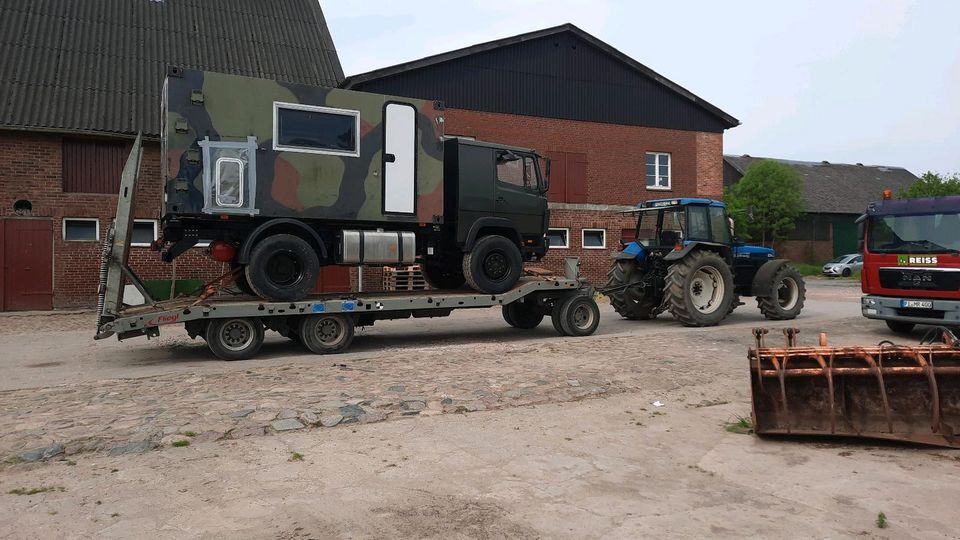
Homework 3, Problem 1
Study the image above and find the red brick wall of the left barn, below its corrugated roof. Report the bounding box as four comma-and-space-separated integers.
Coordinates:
0, 131, 221, 308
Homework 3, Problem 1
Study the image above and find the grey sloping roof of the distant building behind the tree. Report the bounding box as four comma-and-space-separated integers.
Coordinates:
723, 155, 918, 214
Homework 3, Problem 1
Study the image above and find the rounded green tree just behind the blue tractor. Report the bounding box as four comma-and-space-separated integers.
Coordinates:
724, 159, 803, 245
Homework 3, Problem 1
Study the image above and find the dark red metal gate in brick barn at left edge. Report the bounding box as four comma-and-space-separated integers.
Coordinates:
0, 219, 53, 311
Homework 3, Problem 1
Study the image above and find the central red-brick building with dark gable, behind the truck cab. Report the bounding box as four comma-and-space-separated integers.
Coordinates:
343, 24, 739, 284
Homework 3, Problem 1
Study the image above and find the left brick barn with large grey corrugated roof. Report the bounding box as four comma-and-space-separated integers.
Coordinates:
0, 0, 346, 310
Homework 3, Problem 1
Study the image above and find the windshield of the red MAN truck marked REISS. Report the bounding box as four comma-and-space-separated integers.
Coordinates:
867, 213, 960, 253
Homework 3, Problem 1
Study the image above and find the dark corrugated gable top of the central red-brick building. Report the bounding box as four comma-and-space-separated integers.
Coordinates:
343, 23, 740, 132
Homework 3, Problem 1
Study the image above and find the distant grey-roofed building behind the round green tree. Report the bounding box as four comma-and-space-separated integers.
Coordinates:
723, 155, 918, 264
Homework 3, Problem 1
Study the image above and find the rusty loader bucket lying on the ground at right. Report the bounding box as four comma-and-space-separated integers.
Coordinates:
748, 328, 960, 448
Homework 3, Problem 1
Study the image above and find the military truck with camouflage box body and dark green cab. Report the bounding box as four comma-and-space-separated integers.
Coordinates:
155, 68, 549, 301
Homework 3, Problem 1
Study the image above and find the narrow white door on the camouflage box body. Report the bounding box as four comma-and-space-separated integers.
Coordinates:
383, 103, 417, 214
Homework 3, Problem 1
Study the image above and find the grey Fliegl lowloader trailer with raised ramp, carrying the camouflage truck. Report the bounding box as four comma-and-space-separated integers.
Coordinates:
95, 137, 600, 360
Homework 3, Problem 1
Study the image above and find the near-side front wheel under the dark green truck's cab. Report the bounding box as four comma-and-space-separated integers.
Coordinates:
463, 234, 523, 294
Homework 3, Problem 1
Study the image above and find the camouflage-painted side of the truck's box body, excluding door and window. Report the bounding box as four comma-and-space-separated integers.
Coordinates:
162, 69, 443, 223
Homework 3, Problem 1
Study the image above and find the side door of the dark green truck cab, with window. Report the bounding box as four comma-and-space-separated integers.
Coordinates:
495, 152, 547, 242
